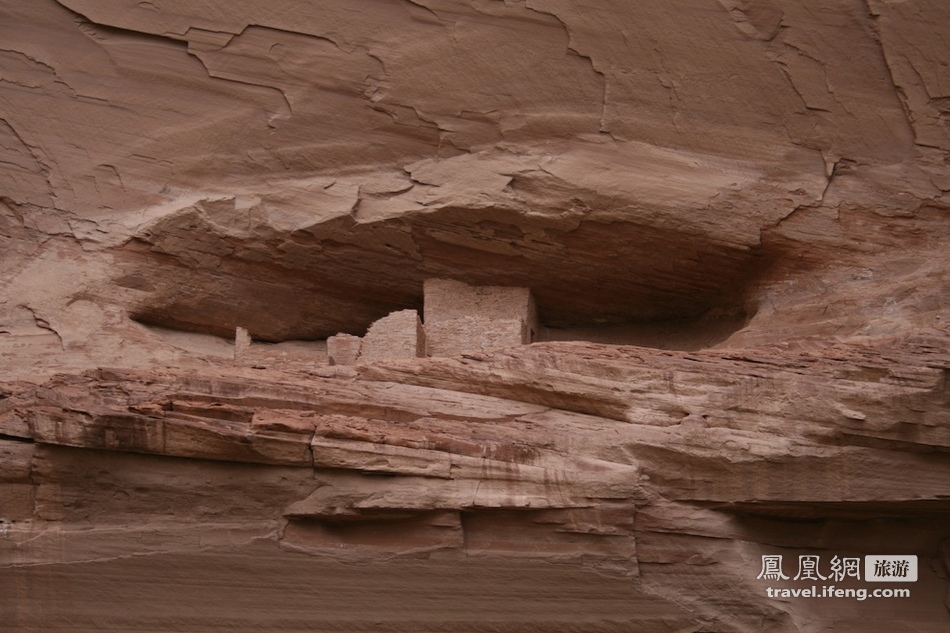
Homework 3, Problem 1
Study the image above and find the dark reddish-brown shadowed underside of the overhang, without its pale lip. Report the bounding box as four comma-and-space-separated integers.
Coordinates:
118, 201, 764, 340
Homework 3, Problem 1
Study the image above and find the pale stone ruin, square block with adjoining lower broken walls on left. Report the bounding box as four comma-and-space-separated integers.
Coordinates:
327, 279, 538, 365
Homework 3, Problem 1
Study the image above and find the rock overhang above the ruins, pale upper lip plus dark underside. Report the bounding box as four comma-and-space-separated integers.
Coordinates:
118, 142, 823, 341
